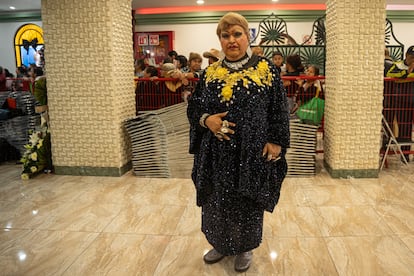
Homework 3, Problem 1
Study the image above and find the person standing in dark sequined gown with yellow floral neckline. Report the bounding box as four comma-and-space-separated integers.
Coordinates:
187, 12, 289, 271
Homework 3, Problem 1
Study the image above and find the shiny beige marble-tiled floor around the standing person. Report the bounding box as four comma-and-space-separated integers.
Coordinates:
0, 157, 414, 276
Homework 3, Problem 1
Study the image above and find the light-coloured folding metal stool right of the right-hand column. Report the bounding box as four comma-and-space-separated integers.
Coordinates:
380, 115, 414, 171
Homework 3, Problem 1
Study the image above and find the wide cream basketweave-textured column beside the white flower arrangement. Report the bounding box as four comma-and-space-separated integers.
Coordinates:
42, 0, 135, 176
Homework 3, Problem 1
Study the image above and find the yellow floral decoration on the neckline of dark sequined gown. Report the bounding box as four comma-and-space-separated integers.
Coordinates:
206, 60, 272, 103
